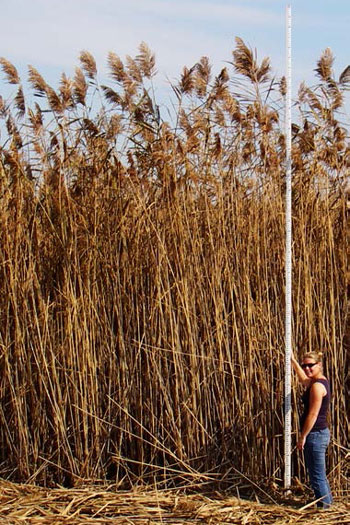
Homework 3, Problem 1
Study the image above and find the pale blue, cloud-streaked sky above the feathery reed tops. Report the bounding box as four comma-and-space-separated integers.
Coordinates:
0, 0, 350, 103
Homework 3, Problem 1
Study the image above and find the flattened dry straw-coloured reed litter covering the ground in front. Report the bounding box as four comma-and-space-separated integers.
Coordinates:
0, 481, 350, 525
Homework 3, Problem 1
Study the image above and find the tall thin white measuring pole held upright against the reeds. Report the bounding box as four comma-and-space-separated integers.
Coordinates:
284, 5, 292, 488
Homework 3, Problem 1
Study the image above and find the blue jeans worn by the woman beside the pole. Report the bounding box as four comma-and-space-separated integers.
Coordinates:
304, 428, 333, 508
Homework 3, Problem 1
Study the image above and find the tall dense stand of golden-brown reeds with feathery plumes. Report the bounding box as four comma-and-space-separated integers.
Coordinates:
0, 39, 350, 489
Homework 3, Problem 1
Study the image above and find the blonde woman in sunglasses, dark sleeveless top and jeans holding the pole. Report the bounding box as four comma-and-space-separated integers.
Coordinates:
292, 352, 333, 508
